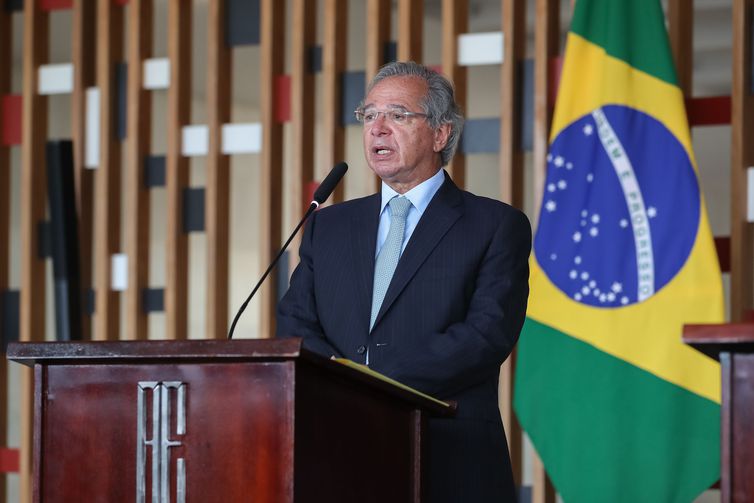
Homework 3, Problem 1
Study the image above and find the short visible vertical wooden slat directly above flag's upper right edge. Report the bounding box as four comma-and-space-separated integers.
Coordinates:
668, 0, 694, 97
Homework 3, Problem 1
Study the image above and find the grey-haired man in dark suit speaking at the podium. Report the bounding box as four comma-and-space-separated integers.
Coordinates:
277, 62, 531, 503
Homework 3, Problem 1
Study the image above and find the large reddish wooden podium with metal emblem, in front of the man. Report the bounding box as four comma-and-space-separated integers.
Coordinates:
7, 339, 448, 503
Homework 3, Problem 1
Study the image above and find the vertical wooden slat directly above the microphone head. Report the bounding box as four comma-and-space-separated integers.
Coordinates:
322, 0, 350, 202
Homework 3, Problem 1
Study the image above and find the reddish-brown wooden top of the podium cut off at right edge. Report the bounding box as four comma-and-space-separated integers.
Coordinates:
683, 323, 754, 359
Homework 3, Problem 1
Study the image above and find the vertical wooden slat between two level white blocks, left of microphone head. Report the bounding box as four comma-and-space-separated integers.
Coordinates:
204, 0, 233, 338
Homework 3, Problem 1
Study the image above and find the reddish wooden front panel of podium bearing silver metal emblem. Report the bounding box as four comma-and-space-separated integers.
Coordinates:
35, 361, 294, 502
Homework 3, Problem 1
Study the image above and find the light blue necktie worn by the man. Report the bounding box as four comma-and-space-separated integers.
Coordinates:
369, 197, 411, 330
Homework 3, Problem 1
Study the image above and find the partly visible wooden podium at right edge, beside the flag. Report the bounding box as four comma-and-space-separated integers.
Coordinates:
683, 323, 754, 503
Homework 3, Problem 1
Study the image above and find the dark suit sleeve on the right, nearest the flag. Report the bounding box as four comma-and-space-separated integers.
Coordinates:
375, 211, 531, 398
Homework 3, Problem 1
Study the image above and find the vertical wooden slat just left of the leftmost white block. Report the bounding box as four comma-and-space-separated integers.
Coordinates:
19, 0, 49, 502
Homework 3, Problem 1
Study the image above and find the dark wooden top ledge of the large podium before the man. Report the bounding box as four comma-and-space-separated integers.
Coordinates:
6, 337, 455, 415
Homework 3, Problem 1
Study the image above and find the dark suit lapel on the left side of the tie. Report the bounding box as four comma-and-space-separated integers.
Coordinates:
350, 193, 382, 331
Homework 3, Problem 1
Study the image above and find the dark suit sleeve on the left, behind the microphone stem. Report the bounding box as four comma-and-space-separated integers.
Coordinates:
276, 213, 342, 357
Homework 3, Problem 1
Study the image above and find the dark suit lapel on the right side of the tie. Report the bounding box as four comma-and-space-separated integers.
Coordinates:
370, 177, 463, 327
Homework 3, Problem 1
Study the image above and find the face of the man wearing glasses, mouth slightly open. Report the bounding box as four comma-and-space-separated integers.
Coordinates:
363, 76, 450, 193
